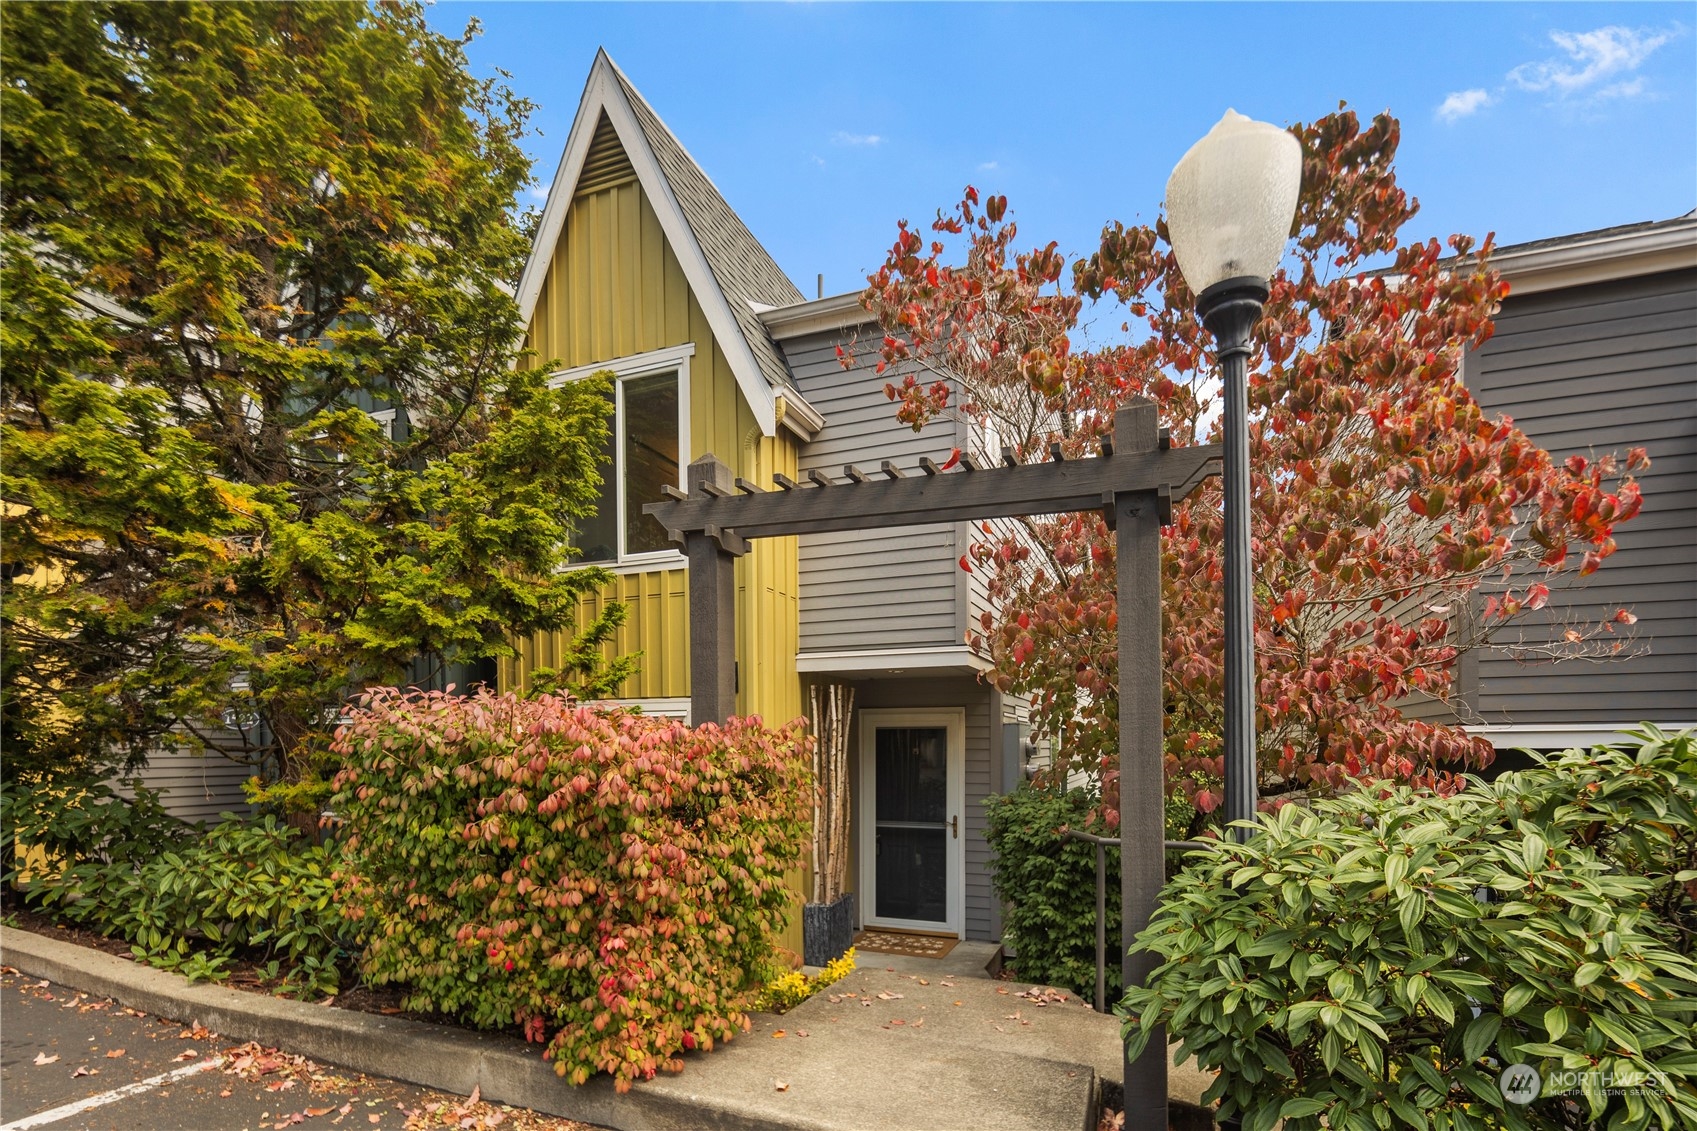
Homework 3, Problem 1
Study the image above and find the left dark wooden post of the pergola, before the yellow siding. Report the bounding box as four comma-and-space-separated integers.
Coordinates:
684, 455, 736, 727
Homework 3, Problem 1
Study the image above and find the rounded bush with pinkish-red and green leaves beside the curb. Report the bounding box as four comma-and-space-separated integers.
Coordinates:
334, 689, 813, 1090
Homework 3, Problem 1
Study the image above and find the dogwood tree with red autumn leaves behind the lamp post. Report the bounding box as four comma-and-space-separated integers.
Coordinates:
864, 110, 1646, 830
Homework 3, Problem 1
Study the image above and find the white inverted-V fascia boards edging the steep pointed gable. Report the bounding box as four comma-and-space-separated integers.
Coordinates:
519, 51, 777, 436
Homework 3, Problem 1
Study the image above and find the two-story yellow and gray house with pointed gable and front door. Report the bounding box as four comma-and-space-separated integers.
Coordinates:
502, 53, 1015, 949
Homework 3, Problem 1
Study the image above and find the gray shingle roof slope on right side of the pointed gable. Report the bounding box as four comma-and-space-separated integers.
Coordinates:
613, 66, 803, 387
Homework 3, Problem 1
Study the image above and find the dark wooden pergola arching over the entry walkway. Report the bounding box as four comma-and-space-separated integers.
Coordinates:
643, 399, 1222, 1128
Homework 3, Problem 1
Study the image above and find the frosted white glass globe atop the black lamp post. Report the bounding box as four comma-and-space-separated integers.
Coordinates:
1166, 110, 1302, 294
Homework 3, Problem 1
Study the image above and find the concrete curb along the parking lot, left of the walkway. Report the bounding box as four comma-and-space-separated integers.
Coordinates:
0, 926, 797, 1131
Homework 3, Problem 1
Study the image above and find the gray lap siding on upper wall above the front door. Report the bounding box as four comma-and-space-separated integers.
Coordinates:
781, 329, 966, 652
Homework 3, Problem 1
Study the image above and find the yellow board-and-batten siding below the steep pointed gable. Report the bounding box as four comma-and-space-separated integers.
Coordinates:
501, 117, 803, 723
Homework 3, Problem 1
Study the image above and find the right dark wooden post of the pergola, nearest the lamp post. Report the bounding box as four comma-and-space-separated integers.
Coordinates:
1113, 397, 1168, 1128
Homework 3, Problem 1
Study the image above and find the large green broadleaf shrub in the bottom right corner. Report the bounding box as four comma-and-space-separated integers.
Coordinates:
1123, 730, 1697, 1131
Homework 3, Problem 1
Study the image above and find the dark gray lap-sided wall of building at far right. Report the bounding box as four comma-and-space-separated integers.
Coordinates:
1463, 270, 1697, 730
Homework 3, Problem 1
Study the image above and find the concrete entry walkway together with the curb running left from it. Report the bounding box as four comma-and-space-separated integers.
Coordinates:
0, 927, 1205, 1131
